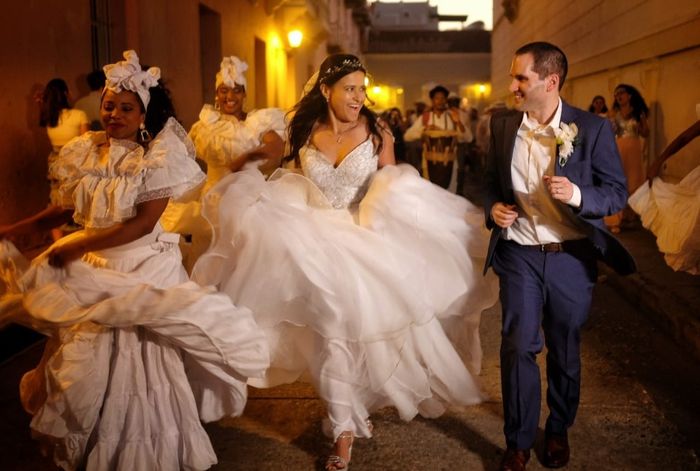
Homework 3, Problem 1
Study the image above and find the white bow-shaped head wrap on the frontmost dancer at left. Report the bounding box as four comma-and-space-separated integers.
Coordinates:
103, 50, 160, 108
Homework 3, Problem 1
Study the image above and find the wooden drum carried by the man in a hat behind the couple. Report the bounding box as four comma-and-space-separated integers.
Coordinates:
421, 129, 457, 189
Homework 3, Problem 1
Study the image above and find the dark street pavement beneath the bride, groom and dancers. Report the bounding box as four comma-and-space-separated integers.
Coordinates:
0, 283, 700, 471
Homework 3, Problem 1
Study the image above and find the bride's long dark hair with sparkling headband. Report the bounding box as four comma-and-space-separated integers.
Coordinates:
284, 54, 382, 167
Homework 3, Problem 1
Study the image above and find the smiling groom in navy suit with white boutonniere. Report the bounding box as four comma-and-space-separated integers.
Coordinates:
484, 42, 635, 471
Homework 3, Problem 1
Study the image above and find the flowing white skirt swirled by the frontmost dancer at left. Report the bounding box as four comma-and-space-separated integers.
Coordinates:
0, 228, 269, 471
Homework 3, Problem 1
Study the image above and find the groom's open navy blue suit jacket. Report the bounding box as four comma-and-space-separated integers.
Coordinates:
484, 101, 636, 275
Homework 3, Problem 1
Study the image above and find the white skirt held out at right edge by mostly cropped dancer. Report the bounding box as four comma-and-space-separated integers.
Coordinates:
629, 167, 700, 275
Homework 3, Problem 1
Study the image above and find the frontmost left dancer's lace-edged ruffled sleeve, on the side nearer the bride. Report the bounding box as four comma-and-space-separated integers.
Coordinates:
136, 118, 206, 204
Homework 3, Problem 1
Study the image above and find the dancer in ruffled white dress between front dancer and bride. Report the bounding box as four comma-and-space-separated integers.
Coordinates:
161, 56, 286, 271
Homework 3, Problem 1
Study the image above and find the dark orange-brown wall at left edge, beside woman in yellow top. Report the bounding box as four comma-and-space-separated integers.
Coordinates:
0, 0, 92, 224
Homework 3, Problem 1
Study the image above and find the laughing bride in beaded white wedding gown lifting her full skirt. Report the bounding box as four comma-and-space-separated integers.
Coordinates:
193, 54, 497, 469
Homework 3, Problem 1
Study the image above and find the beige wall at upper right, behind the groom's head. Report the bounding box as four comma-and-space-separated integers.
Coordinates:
491, 0, 700, 180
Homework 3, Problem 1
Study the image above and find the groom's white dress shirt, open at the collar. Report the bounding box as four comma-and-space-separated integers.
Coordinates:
503, 99, 585, 245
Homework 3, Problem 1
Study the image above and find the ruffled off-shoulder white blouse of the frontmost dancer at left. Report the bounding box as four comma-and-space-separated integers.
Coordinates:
49, 118, 206, 228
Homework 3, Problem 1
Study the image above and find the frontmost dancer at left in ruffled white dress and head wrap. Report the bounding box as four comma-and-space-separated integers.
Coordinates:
0, 51, 269, 471
